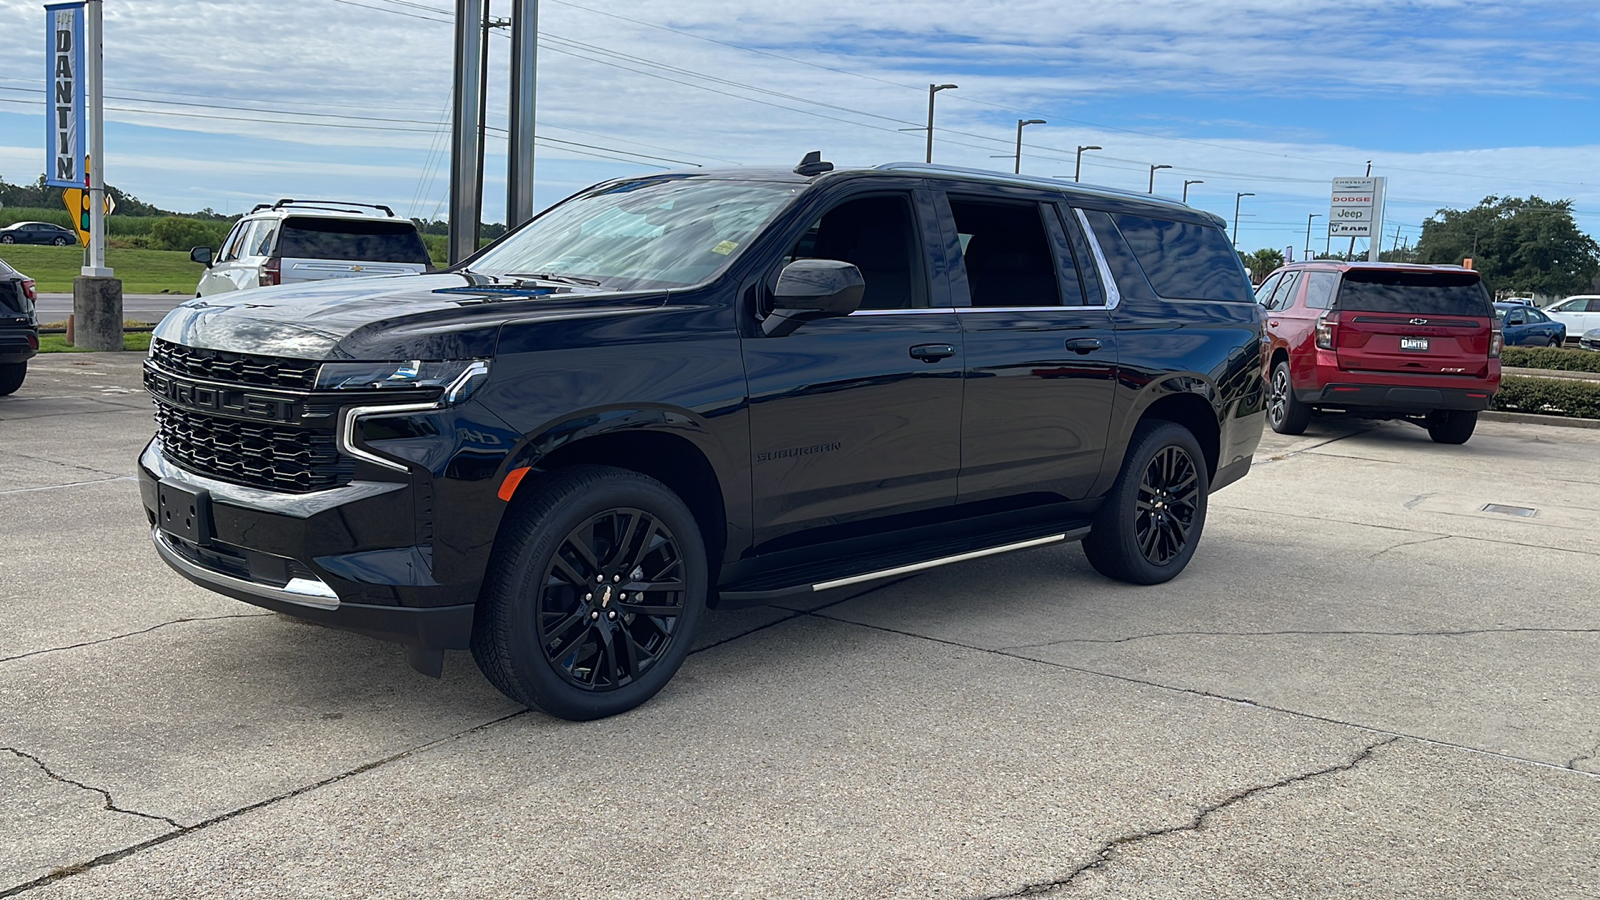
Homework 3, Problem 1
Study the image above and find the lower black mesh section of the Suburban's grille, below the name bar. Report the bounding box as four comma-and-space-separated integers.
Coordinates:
155, 393, 355, 493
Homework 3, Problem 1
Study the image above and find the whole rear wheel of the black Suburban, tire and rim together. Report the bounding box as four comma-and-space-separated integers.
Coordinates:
1083, 420, 1211, 585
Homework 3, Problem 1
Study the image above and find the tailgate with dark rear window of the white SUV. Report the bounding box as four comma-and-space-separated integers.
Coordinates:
274, 216, 429, 285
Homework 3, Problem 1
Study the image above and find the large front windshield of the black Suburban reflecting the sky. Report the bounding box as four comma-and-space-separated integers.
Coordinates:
470, 176, 803, 290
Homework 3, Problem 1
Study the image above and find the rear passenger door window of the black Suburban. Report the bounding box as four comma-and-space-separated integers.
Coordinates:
950, 195, 1062, 306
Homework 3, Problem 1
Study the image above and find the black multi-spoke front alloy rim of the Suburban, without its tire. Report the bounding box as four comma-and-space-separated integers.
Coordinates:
534, 509, 686, 692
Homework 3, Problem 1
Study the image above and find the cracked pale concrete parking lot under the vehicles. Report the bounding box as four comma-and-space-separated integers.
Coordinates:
0, 354, 1600, 900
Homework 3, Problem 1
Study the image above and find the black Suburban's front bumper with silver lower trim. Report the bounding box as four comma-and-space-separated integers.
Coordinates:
139, 440, 478, 650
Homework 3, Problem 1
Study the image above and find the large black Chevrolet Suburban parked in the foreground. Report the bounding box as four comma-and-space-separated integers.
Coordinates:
139, 154, 1264, 719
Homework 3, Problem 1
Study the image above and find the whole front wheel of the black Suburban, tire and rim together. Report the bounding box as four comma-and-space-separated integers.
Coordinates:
472, 466, 709, 721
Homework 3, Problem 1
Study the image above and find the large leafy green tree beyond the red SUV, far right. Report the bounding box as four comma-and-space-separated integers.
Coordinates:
1416, 197, 1600, 296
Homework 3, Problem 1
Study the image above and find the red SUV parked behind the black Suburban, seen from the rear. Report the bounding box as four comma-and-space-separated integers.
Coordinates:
1256, 259, 1501, 444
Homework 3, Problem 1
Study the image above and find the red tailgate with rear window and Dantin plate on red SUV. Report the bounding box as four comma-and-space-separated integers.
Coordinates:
1333, 269, 1494, 378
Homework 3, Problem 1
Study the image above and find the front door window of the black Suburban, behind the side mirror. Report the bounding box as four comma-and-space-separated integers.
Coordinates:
766, 194, 928, 309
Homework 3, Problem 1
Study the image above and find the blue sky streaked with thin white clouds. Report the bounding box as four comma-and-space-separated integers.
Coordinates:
0, 0, 1600, 250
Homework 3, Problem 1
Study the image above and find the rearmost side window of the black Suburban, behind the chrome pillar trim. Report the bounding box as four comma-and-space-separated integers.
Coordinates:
1112, 213, 1254, 303
